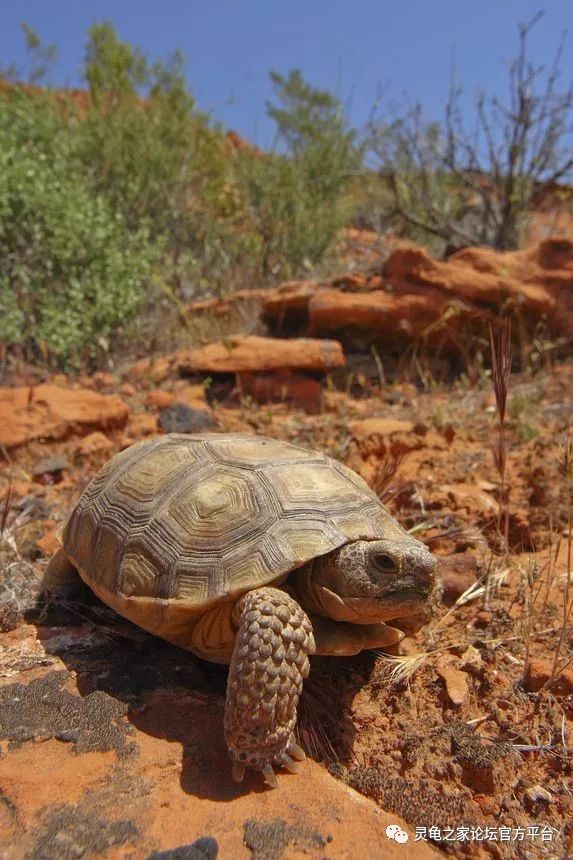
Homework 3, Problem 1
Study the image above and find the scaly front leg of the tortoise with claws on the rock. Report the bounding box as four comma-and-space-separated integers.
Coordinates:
225, 588, 315, 788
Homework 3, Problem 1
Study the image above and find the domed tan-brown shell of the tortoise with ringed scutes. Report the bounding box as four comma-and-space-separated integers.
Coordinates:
64, 434, 405, 609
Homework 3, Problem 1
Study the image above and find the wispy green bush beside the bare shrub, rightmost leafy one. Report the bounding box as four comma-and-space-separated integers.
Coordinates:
235, 69, 361, 276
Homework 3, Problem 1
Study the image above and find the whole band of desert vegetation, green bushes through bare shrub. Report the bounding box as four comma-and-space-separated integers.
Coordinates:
0, 15, 573, 367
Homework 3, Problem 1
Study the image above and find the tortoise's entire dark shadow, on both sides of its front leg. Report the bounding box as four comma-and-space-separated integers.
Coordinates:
28, 582, 374, 802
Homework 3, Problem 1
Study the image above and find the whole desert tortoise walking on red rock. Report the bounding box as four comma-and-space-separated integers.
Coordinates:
48, 433, 436, 786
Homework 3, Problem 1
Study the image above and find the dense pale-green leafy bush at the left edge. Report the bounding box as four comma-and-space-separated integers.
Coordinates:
0, 90, 156, 363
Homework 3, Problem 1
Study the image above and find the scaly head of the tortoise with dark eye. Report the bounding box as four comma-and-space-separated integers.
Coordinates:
300, 534, 437, 624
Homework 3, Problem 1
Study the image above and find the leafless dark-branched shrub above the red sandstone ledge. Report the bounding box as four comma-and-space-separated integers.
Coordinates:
371, 12, 573, 249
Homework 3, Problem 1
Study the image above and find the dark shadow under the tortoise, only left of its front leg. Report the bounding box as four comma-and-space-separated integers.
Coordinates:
27, 581, 241, 801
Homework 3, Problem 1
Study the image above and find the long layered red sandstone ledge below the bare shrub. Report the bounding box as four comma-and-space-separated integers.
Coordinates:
264, 239, 573, 348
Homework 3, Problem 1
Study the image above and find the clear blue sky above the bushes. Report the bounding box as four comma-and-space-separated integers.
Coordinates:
0, 0, 573, 146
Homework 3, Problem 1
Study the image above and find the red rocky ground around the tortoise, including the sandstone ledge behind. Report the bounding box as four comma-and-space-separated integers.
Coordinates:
0, 241, 573, 860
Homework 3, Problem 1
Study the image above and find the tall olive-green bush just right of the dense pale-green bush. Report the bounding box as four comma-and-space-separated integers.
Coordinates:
80, 24, 248, 295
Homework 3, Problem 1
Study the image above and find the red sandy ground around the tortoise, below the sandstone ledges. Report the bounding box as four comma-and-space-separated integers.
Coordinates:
0, 352, 573, 860
